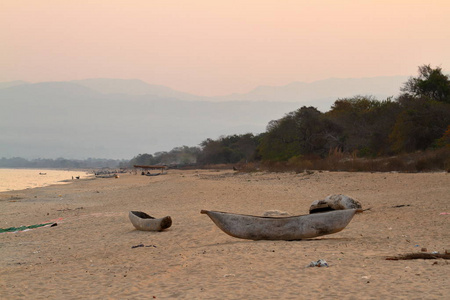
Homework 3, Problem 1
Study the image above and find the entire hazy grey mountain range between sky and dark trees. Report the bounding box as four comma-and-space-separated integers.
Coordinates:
0, 76, 407, 159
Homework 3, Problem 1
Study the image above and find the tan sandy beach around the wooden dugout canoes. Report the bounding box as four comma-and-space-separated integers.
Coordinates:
0, 170, 450, 299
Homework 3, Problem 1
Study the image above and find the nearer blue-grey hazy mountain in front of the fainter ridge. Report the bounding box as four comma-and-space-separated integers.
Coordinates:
0, 82, 299, 159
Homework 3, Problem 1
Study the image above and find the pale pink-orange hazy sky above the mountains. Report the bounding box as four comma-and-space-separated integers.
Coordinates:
0, 0, 450, 96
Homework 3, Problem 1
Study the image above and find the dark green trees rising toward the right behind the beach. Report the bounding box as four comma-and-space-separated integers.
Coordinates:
131, 65, 450, 170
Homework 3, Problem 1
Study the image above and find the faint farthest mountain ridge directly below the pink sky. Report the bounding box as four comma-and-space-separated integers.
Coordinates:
72, 76, 408, 111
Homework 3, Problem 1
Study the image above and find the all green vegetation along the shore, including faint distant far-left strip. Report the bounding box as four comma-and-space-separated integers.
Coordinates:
4, 65, 450, 172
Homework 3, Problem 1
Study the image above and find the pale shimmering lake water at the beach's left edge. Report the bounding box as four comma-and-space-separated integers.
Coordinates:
0, 169, 92, 192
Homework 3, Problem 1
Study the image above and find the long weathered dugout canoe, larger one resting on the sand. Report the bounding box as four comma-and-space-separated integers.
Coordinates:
201, 209, 356, 241
